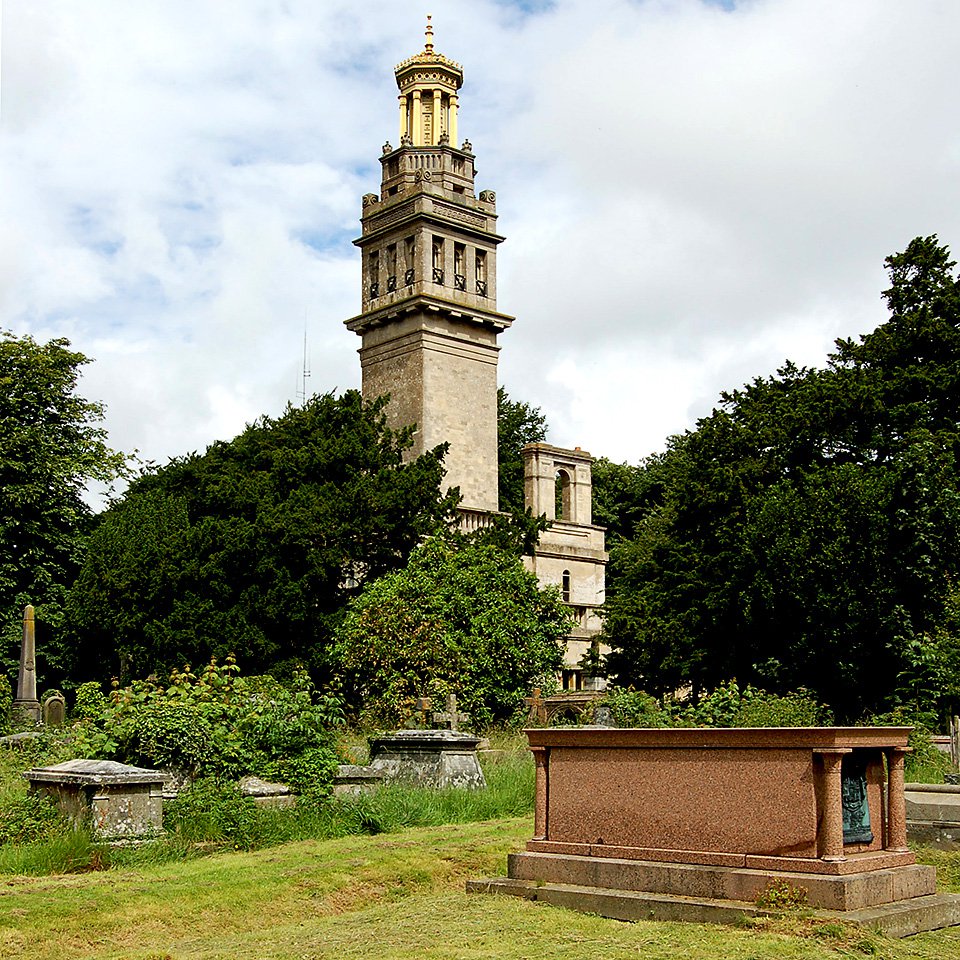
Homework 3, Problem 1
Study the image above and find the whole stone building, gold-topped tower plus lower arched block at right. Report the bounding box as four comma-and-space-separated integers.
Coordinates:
346, 18, 607, 689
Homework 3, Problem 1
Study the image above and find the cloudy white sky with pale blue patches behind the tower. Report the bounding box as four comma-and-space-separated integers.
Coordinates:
0, 0, 960, 496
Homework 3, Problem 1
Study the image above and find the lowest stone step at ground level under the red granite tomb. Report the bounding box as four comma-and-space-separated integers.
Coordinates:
466, 877, 960, 937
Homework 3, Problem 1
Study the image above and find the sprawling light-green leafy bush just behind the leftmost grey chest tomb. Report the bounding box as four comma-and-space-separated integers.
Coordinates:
75, 657, 343, 792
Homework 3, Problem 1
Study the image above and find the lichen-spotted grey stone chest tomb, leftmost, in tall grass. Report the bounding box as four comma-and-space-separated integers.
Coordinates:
23, 760, 164, 840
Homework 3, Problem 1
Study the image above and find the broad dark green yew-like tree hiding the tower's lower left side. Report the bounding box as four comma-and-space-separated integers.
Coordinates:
69, 391, 457, 679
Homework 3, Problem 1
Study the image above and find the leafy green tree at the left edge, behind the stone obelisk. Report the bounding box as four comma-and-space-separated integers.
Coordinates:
0, 330, 124, 685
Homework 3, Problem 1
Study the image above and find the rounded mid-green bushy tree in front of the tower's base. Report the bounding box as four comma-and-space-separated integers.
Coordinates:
337, 537, 570, 723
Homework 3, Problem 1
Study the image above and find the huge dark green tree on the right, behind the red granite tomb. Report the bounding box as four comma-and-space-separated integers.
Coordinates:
606, 237, 960, 719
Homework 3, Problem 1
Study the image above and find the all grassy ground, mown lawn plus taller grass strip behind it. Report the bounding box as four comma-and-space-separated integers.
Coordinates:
0, 741, 960, 960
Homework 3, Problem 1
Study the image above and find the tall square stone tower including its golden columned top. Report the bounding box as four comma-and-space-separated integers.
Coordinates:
346, 17, 513, 512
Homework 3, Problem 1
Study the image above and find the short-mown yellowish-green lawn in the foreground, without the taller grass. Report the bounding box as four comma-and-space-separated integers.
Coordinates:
0, 817, 960, 960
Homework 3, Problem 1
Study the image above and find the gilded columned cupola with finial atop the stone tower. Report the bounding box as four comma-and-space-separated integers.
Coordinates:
395, 16, 463, 147
